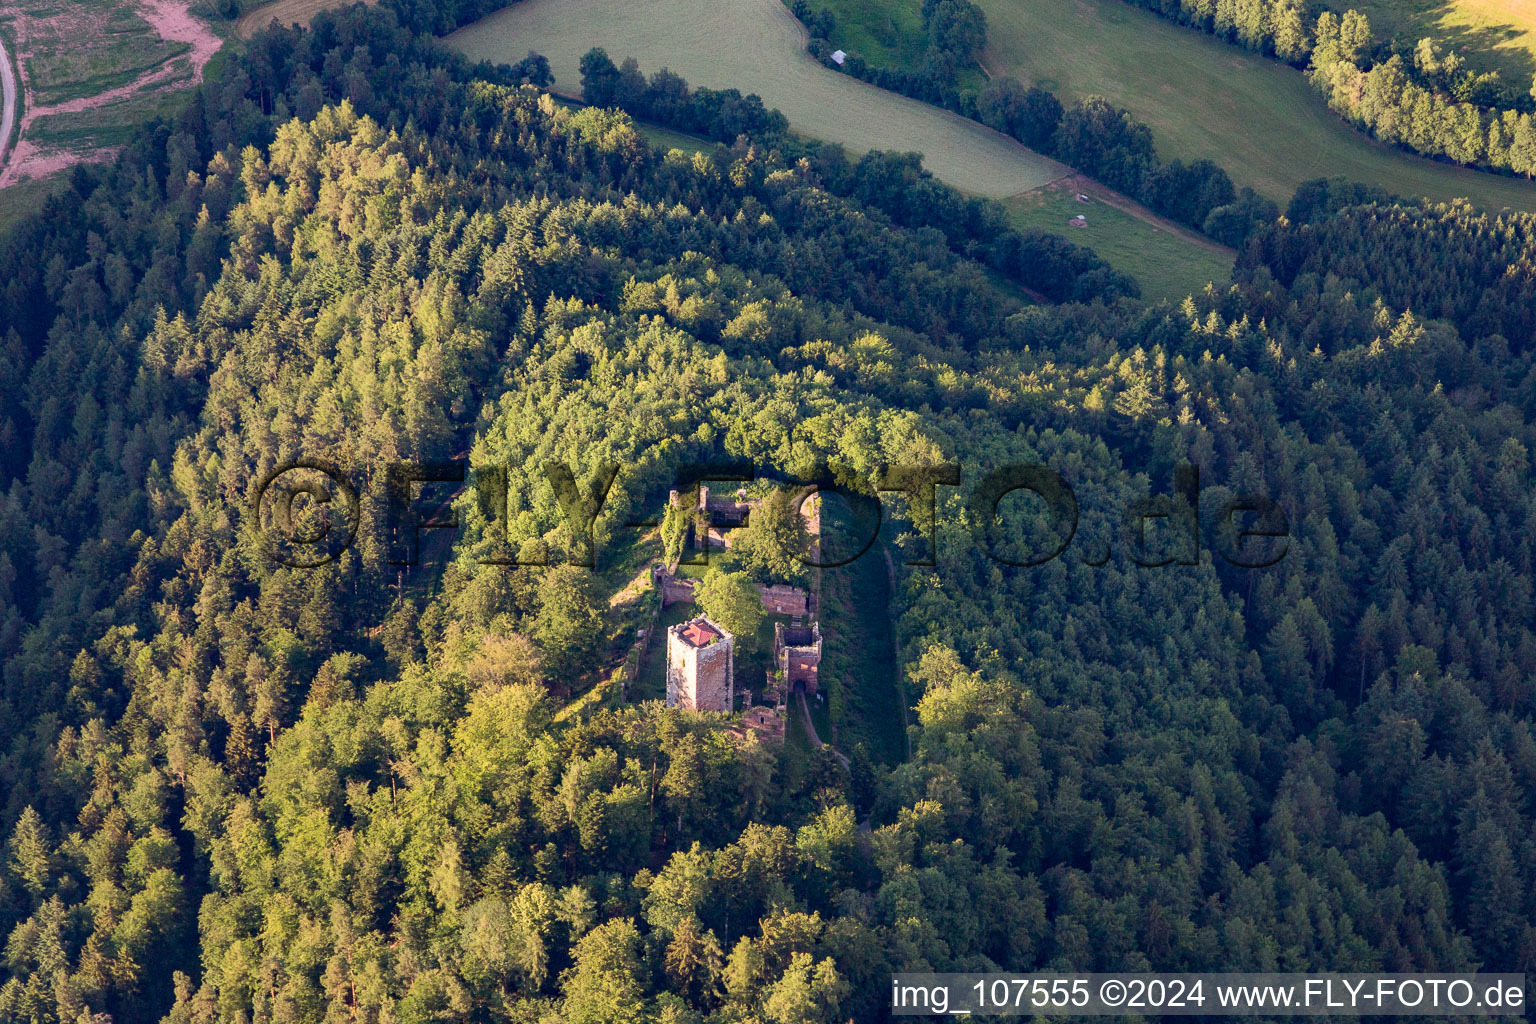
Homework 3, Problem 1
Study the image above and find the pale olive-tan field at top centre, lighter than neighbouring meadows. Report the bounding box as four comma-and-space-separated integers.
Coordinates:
449, 0, 1068, 198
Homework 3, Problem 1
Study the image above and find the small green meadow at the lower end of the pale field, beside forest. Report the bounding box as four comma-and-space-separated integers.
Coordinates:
1003, 178, 1235, 302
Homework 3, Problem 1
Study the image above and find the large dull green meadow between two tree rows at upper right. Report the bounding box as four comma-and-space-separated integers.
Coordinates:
976, 0, 1536, 210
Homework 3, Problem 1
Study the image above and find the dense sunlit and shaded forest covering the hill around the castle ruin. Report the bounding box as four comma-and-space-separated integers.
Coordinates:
0, 8, 1536, 1024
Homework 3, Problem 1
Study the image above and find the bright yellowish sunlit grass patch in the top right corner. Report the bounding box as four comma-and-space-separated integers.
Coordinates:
1349, 0, 1536, 86
